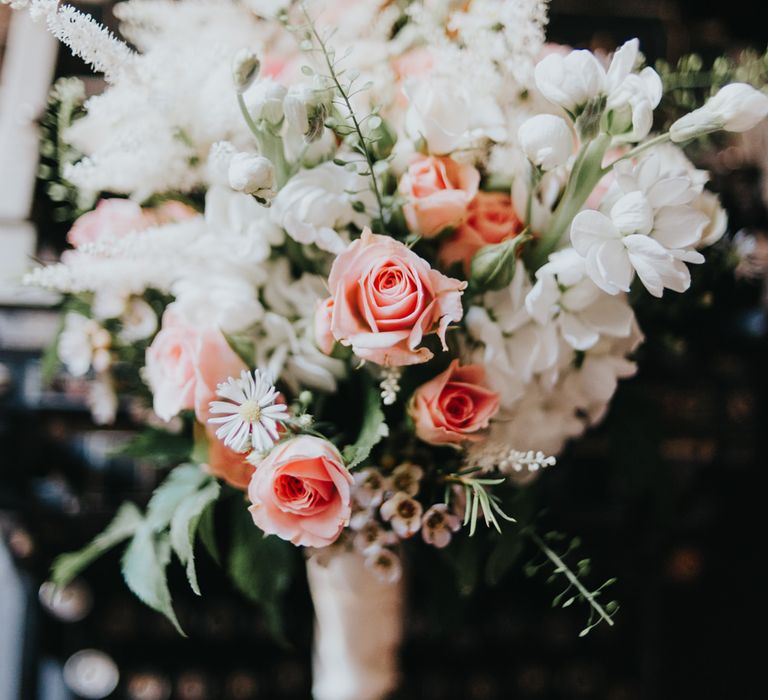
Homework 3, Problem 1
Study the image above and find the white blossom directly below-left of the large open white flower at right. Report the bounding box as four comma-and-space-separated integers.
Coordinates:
525, 248, 634, 350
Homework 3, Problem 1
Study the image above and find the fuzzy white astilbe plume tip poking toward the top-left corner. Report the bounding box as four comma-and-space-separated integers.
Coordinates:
29, 0, 136, 83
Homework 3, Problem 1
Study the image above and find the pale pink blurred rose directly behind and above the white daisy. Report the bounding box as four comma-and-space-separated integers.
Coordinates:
145, 313, 248, 424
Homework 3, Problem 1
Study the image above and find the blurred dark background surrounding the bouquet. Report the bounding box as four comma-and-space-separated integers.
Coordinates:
0, 0, 768, 700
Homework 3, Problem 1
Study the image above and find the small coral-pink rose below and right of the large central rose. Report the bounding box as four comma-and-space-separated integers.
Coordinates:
408, 360, 499, 445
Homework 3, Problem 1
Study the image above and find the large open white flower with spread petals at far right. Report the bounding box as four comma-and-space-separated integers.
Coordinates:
571, 154, 709, 297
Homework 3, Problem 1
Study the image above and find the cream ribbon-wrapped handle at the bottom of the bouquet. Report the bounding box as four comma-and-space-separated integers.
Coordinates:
307, 552, 403, 700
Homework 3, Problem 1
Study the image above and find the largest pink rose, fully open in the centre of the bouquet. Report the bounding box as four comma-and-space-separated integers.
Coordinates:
328, 229, 467, 367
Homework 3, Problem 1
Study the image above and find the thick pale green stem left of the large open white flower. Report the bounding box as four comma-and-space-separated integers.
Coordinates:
529, 134, 611, 270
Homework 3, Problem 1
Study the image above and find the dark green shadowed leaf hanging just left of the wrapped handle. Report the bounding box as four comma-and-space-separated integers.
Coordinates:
227, 499, 296, 644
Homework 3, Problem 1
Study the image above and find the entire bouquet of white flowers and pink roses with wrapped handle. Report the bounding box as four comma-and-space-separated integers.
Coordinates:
7, 0, 768, 700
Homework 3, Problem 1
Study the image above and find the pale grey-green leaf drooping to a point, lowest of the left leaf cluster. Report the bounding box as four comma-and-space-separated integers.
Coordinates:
122, 520, 187, 637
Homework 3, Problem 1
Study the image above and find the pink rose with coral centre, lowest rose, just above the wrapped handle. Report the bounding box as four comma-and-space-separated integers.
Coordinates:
248, 435, 352, 547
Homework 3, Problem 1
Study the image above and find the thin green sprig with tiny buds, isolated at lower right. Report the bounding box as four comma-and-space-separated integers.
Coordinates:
525, 527, 619, 637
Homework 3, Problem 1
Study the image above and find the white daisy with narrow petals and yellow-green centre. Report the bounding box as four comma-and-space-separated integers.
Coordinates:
208, 369, 288, 452
